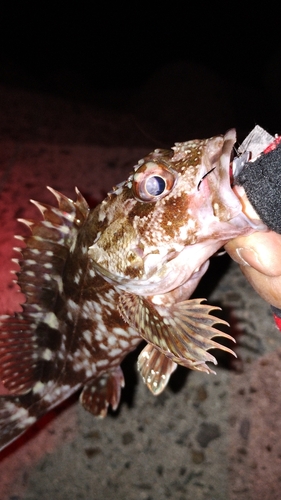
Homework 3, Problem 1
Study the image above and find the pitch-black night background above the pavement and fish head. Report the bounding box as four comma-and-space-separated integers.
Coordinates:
0, 1, 281, 140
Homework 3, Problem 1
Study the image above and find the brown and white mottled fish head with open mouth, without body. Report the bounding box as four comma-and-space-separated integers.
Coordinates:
89, 129, 256, 294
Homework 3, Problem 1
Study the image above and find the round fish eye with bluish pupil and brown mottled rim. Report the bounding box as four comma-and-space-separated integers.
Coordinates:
133, 161, 176, 202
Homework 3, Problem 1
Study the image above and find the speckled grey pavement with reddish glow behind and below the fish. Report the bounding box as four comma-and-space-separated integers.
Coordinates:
0, 71, 281, 500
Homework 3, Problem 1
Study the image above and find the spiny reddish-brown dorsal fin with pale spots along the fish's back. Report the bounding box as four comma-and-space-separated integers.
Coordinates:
0, 188, 89, 394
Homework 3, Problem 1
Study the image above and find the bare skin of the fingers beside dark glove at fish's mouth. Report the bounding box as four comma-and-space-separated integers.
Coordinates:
225, 188, 281, 309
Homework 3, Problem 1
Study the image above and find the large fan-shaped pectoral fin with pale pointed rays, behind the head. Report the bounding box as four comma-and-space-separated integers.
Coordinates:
119, 293, 236, 373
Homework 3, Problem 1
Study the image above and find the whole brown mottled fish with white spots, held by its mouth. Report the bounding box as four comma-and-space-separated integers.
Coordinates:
0, 129, 258, 449
